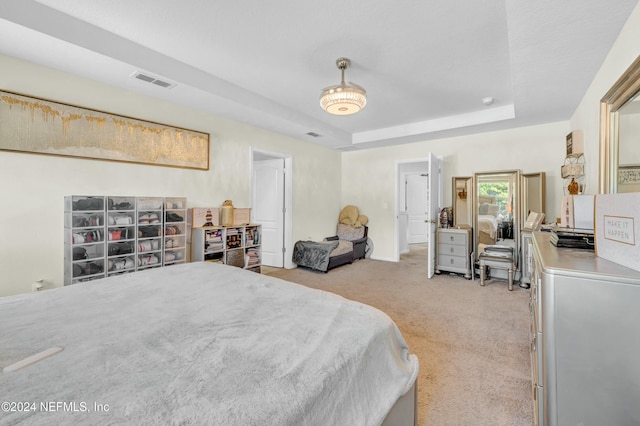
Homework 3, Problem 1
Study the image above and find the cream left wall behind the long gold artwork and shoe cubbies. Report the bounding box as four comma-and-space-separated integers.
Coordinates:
0, 56, 341, 296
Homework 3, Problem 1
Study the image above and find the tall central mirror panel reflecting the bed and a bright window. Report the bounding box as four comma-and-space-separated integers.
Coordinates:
473, 170, 521, 260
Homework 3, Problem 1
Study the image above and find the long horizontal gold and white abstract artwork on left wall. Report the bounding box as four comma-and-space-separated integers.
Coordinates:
0, 91, 209, 170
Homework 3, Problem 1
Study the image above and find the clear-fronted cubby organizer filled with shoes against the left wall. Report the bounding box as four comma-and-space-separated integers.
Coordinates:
64, 195, 187, 285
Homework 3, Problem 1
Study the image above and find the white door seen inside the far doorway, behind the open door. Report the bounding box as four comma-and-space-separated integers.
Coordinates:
405, 173, 429, 244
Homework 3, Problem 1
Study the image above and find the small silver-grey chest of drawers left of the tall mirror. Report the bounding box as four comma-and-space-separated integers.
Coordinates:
435, 228, 471, 279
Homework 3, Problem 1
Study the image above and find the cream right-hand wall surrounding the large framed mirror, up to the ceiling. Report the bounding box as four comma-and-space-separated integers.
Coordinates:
571, 3, 640, 194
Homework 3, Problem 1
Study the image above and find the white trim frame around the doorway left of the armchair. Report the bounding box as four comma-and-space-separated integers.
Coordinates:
249, 147, 296, 269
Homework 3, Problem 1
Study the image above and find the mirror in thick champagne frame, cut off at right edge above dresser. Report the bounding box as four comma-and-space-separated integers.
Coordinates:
598, 56, 640, 194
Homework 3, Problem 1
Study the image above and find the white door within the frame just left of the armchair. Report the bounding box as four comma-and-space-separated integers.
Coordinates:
251, 158, 284, 268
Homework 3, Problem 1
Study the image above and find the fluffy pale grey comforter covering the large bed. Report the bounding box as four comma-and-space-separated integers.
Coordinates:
0, 262, 418, 425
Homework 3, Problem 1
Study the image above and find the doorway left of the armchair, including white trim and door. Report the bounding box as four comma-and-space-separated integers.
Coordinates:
251, 149, 294, 269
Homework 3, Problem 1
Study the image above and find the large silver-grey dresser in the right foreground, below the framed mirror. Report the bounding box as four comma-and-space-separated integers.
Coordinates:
530, 232, 640, 426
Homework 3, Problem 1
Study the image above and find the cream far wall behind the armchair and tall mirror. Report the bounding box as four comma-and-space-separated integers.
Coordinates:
342, 121, 569, 261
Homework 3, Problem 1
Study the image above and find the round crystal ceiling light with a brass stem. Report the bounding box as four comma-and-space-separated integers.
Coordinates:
320, 58, 367, 115
